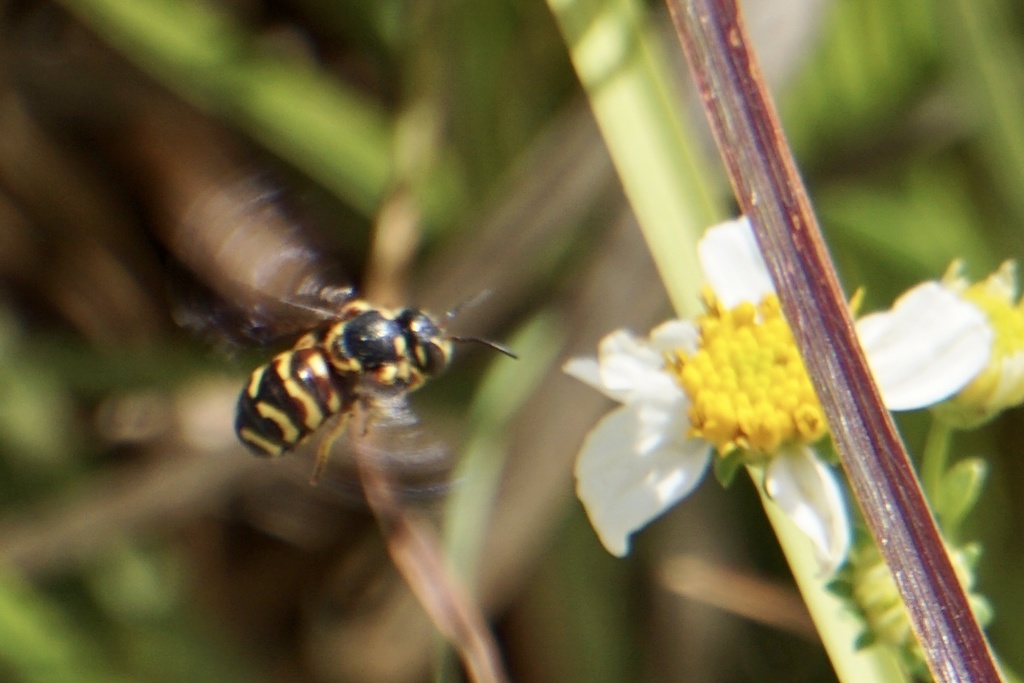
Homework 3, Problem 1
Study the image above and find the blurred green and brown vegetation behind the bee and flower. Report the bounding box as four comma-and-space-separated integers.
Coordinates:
0, 0, 1024, 683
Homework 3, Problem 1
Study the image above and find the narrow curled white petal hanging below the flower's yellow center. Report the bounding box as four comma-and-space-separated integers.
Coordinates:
765, 447, 850, 577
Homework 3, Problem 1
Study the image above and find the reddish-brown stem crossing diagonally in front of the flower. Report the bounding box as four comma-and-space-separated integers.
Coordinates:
668, 0, 999, 681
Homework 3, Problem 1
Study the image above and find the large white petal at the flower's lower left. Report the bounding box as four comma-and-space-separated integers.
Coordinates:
575, 405, 710, 557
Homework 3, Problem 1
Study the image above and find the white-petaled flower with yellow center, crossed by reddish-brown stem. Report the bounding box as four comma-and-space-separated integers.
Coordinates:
564, 218, 991, 573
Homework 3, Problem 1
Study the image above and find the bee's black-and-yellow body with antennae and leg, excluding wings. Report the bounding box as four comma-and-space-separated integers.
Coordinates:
234, 298, 515, 483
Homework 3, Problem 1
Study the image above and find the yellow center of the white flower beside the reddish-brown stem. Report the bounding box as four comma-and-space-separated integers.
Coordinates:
668, 290, 826, 455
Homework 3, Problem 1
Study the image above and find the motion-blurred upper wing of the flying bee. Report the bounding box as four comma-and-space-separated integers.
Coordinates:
165, 177, 354, 346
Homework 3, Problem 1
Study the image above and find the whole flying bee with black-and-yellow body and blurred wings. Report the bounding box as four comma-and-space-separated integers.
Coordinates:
167, 176, 514, 481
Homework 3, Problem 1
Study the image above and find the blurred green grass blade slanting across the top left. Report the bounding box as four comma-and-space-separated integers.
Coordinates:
51, 0, 460, 223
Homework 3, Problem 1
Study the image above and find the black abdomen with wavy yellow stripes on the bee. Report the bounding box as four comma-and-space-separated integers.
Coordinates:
234, 348, 353, 457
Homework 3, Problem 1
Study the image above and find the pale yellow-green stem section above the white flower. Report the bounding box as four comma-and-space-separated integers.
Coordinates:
548, 0, 722, 315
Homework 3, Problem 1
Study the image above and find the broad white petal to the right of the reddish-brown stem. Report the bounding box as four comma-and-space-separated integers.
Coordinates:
857, 282, 992, 411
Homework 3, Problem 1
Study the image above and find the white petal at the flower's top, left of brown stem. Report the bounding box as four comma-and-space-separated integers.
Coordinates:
697, 216, 775, 308
